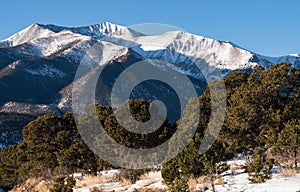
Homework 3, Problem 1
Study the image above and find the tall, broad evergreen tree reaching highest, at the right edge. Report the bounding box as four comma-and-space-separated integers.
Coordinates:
226, 63, 300, 152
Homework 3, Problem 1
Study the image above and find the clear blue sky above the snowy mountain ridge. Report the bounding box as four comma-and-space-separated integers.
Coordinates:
0, 0, 300, 56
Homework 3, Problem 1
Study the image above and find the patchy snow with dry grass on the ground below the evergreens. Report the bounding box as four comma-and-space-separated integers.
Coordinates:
74, 157, 300, 192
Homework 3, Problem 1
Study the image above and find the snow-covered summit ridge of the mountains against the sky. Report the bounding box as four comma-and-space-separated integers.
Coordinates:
0, 22, 300, 70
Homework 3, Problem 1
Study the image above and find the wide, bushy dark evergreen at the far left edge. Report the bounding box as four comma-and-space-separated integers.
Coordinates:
0, 114, 97, 188
